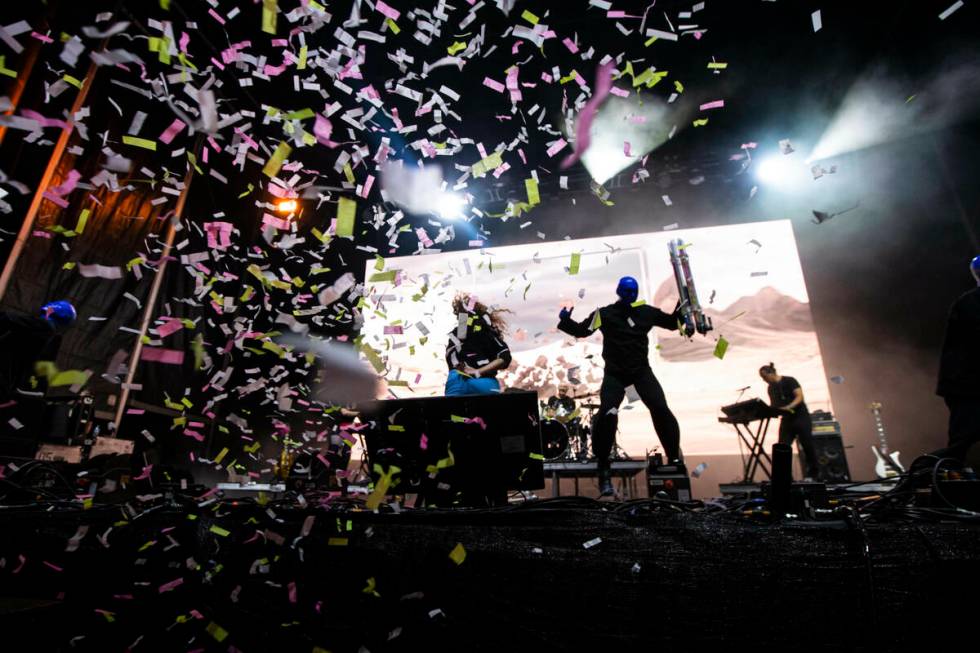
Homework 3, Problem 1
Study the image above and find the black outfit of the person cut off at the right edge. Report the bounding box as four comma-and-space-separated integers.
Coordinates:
933, 287, 980, 461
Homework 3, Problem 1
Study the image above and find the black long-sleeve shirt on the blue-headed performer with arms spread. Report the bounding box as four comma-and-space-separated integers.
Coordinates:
558, 301, 677, 379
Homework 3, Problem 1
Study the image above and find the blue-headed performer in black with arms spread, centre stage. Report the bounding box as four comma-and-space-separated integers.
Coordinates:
558, 277, 681, 496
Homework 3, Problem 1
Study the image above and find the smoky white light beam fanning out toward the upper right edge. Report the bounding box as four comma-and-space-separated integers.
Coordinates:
809, 52, 980, 161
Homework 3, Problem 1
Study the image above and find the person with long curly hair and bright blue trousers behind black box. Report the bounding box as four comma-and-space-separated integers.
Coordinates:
446, 295, 511, 397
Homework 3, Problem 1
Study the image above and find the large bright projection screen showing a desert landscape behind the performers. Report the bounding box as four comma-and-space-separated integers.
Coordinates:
362, 220, 831, 458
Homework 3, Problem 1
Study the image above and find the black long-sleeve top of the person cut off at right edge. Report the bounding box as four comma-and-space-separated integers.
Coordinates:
936, 287, 980, 397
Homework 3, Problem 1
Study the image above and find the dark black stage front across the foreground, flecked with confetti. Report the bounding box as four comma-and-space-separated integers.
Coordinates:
0, 497, 980, 652
